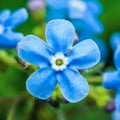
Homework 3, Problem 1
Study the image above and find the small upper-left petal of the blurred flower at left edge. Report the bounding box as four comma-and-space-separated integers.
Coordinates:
0, 9, 11, 23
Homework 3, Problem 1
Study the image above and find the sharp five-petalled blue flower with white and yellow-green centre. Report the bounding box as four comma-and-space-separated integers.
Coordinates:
18, 19, 100, 102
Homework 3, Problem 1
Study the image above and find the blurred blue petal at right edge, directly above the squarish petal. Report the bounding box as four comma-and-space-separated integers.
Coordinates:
114, 47, 120, 70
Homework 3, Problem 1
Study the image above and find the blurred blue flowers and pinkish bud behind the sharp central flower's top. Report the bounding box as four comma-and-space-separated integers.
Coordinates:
28, 0, 108, 62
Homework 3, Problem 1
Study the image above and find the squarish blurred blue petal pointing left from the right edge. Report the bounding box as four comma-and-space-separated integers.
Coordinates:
103, 71, 120, 89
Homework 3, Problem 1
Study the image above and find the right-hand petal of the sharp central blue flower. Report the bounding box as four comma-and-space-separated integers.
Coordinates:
68, 39, 100, 69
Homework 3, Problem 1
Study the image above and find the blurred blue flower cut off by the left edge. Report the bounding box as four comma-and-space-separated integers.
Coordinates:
0, 8, 28, 48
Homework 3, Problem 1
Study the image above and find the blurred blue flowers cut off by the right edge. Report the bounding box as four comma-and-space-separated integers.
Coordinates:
103, 32, 120, 120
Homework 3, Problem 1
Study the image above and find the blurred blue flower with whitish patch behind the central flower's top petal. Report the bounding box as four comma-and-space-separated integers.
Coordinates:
46, 0, 104, 37
